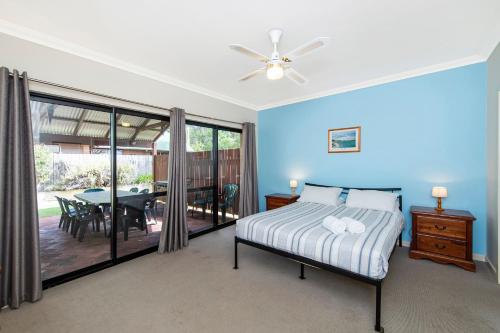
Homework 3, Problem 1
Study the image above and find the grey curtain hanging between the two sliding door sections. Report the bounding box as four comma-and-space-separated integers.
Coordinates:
158, 108, 188, 253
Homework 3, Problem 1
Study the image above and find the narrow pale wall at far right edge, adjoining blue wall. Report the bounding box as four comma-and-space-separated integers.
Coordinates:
486, 44, 500, 283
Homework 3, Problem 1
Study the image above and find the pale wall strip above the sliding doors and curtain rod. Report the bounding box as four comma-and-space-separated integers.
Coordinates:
0, 33, 257, 127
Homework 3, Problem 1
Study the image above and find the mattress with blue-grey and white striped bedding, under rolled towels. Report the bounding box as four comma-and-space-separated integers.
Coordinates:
236, 202, 404, 279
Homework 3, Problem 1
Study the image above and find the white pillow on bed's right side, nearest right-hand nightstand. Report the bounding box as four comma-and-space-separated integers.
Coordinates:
345, 189, 399, 212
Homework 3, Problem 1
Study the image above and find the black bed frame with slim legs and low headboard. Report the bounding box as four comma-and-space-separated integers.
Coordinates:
233, 183, 403, 332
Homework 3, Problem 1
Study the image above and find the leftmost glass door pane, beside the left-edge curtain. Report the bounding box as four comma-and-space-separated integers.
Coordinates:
31, 98, 111, 280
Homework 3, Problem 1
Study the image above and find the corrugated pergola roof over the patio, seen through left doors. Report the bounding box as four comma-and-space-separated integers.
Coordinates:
31, 101, 169, 142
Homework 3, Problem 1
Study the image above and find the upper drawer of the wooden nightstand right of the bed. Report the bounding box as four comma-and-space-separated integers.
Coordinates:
417, 215, 467, 240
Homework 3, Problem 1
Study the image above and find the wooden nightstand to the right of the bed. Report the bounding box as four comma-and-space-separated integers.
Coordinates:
410, 206, 476, 272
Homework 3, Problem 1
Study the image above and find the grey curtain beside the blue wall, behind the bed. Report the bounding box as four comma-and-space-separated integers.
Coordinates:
239, 123, 259, 218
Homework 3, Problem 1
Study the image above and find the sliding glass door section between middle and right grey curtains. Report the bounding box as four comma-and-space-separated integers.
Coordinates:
186, 122, 241, 228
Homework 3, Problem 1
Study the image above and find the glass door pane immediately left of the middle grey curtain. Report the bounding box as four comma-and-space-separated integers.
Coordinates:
115, 110, 170, 257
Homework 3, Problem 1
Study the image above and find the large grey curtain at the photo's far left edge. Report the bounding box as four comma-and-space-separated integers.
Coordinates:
0, 67, 42, 309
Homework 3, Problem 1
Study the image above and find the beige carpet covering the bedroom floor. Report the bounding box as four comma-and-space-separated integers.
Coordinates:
0, 227, 500, 333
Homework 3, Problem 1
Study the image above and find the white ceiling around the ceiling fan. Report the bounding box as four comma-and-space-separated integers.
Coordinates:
0, 0, 500, 109
